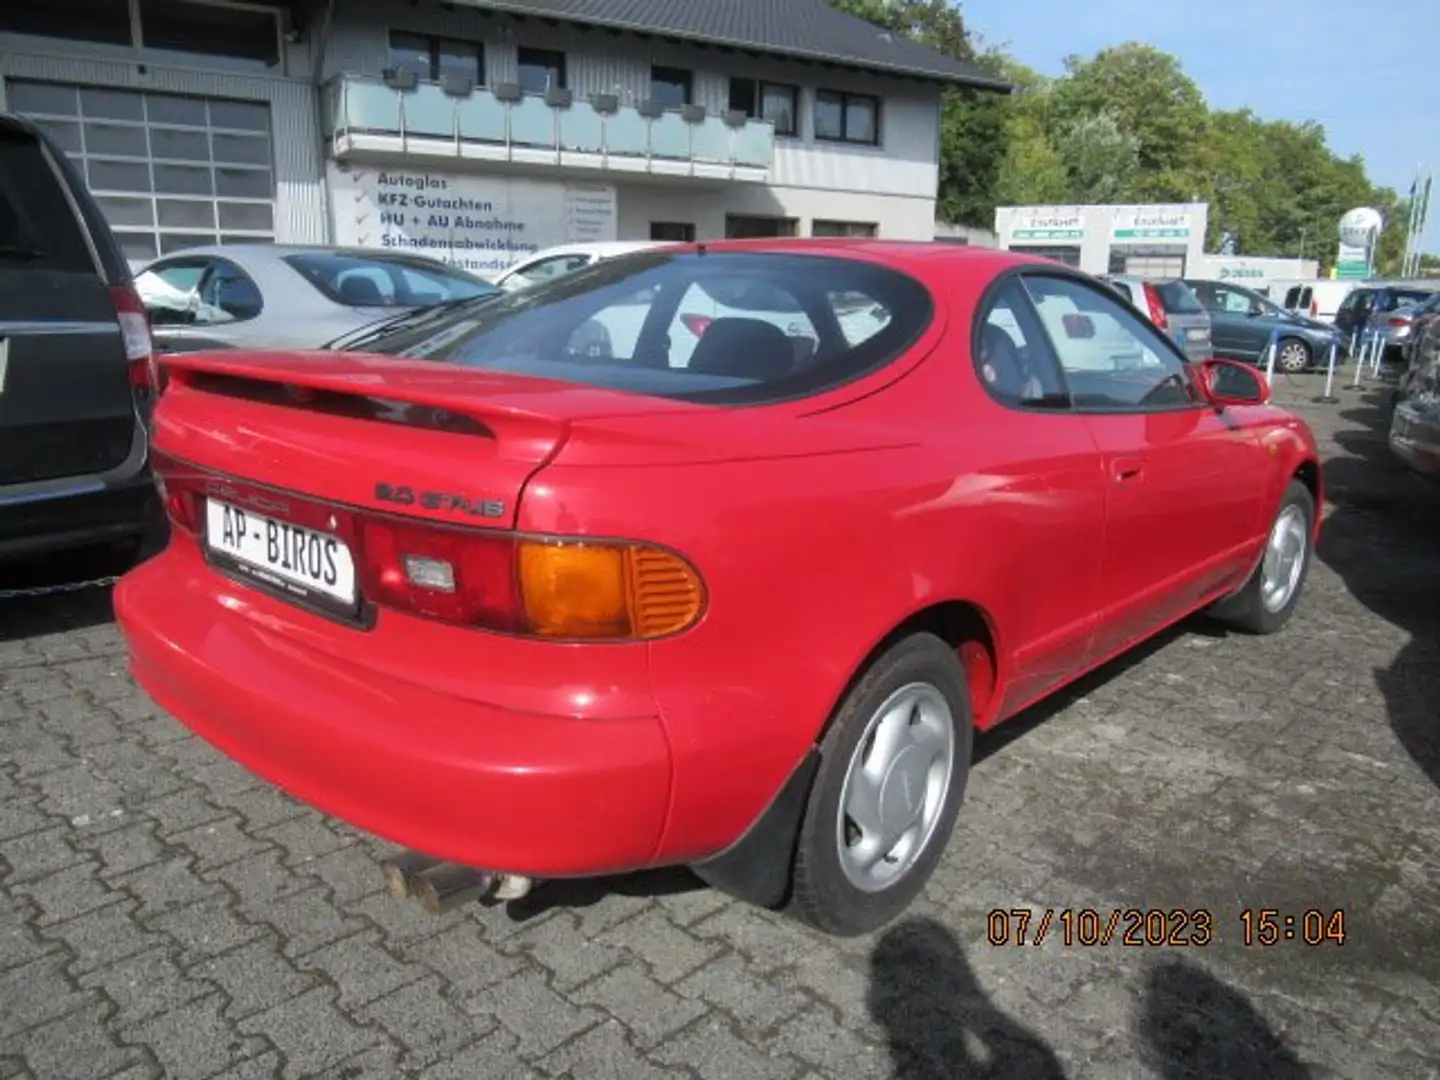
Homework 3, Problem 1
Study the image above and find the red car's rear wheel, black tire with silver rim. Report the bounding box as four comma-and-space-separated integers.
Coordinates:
789, 634, 975, 937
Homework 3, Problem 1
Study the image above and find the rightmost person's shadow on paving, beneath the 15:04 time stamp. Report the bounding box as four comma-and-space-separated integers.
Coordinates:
1136, 960, 1313, 1080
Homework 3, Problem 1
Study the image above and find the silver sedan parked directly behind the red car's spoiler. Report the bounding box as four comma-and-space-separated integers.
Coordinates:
135, 243, 498, 353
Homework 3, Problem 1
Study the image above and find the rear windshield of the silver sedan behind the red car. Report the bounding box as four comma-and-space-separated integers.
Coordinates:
285, 252, 500, 308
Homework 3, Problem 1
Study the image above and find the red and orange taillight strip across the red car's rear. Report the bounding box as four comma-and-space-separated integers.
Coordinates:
153, 454, 706, 641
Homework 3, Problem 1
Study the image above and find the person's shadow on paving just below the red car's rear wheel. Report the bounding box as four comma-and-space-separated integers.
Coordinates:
868, 919, 1066, 1080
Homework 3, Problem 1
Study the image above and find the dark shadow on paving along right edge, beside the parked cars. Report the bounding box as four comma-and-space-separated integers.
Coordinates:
1316, 393, 1440, 786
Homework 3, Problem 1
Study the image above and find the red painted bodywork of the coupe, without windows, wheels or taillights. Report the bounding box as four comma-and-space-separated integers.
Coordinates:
115, 240, 1319, 921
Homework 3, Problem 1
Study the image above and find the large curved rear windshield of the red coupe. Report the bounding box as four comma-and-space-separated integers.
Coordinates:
367, 251, 933, 405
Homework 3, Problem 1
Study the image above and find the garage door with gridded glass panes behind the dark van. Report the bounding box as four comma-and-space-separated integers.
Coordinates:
6, 81, 275, 264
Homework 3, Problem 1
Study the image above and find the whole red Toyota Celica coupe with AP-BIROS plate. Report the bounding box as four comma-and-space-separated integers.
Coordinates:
115, 240, 1322, 933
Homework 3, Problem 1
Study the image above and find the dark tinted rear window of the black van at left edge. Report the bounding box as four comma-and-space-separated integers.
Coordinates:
0, 127, 95, 274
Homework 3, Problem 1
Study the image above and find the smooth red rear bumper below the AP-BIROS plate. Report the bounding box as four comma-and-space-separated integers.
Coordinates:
115, 544, 671, 877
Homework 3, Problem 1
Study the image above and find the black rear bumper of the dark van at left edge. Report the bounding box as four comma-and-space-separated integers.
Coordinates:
0, 469, 164, 559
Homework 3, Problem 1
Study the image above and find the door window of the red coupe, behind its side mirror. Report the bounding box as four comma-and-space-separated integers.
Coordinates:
1025, 275, 1197, 412
